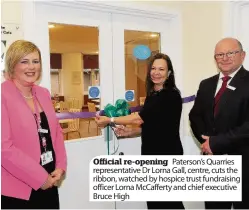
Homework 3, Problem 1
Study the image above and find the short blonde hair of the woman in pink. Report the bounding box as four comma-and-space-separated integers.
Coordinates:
5, 40, 42, 80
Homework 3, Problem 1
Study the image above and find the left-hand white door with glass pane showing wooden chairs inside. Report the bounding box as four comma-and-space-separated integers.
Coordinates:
33, 3, 114, 209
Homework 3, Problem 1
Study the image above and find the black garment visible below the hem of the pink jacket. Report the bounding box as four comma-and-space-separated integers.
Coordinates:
1, 187, 60, 209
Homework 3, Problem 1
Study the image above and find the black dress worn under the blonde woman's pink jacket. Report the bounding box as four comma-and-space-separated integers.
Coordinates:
1, 112, 59, 209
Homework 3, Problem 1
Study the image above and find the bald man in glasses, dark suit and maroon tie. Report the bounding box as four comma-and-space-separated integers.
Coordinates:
189, 38, 249, 209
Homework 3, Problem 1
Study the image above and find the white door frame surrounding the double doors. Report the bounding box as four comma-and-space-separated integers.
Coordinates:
22, 0, 184, 139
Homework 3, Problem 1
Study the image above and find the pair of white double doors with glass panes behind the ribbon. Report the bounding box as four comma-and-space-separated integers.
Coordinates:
30, 2, 182, 209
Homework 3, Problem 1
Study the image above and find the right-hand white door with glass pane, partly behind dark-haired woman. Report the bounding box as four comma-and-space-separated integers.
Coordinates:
112, 14, 184, 209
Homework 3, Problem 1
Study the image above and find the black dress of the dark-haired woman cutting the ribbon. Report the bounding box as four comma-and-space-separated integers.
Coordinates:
139, 89, 184, 209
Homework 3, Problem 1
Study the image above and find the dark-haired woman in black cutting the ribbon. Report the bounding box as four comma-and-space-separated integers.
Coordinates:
96, 53, 184, 209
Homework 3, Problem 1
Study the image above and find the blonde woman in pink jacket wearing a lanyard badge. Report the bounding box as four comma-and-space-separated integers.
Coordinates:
1, 40, 67, 209
